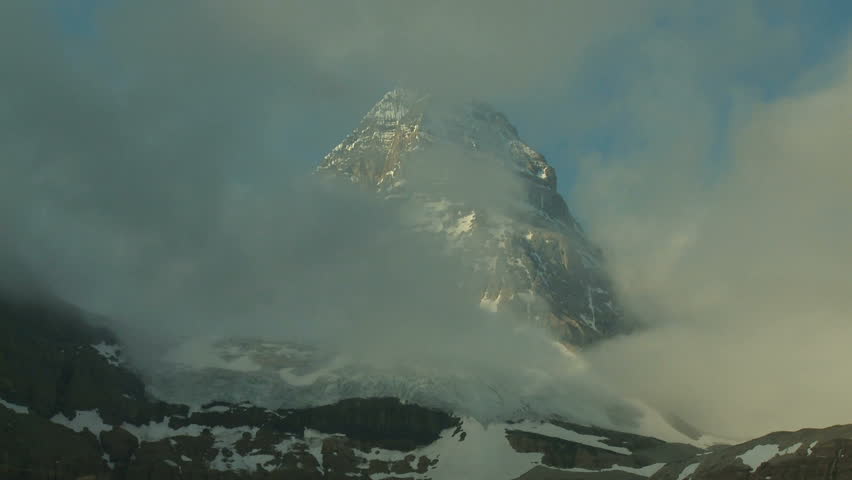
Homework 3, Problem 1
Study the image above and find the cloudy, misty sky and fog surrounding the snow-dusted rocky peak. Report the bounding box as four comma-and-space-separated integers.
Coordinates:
0, 0, 852, 446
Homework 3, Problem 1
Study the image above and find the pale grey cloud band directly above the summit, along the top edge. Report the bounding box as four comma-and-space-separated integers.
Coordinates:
183, 0, 659, 96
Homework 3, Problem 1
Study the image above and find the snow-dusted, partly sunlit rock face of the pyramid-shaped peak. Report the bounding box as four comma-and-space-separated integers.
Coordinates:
317, 90, 628, 347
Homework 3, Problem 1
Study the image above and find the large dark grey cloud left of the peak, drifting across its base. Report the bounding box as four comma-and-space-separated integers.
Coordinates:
0, 2, 636, 424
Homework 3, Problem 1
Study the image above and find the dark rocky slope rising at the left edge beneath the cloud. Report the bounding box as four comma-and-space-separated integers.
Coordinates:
0, 297, 186, 423
